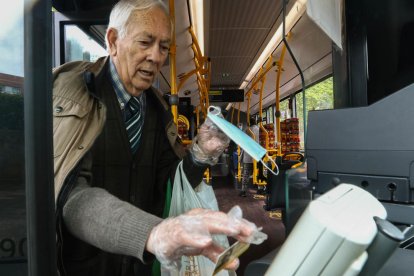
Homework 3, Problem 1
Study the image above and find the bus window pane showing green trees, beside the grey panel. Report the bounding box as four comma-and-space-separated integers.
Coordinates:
295, 77, 333, 149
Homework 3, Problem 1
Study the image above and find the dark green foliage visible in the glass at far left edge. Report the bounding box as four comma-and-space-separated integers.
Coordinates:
0, 93, 24, 129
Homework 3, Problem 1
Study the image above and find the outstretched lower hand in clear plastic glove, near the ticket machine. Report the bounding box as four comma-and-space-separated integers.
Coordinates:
147, 206, 267, 270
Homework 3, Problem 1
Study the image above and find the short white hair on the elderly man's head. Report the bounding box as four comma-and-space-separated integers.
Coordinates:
105, 0, 169, 50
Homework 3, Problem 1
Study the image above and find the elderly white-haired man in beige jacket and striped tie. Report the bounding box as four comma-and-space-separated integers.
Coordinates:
53, 0, 262, 276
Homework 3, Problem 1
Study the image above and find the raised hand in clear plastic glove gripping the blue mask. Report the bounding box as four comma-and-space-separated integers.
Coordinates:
190, 106, 230, 165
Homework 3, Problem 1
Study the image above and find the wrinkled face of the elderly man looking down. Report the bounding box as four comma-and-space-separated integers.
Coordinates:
107, 7, 171, 96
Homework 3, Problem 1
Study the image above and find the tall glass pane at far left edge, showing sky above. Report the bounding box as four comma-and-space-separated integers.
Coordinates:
0, 0, 27, 275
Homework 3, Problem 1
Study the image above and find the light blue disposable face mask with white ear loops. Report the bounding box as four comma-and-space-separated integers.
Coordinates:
207, 106, 279, 175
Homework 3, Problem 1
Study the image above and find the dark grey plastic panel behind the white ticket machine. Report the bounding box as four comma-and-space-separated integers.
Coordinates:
306, 84, 414, 224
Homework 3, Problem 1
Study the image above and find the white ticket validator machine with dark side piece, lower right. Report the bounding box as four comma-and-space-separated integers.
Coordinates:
265, 184, 404, 276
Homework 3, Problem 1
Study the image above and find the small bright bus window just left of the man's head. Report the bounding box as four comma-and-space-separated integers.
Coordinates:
64, 25, 108, 62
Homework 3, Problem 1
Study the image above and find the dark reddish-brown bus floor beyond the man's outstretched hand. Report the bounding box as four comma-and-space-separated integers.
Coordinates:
211, 174, 285, 276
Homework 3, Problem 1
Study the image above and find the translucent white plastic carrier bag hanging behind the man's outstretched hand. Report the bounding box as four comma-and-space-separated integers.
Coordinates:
161, 162, 233, 276
